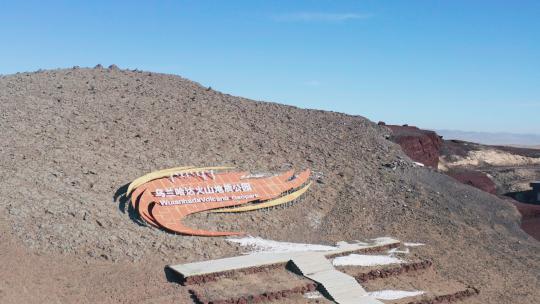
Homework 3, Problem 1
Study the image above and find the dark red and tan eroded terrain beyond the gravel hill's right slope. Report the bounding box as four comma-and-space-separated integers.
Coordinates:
379, 122, 540, 240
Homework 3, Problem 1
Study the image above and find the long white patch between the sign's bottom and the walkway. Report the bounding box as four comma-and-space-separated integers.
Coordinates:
227, 236, 337, 253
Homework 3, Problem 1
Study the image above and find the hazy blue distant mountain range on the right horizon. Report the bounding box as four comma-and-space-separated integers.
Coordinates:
435, 130, 540, 148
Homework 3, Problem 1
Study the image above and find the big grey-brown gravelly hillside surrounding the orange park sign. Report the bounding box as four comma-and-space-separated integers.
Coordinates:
0, 67, 540, 303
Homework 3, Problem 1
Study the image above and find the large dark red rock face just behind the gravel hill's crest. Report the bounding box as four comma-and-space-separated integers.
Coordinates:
379, 123, 443, 168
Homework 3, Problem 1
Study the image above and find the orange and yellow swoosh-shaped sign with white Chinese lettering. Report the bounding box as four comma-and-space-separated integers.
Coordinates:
127, 167, 311, 236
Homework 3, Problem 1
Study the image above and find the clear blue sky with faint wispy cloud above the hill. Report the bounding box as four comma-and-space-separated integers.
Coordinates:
0, 0, 540, 134
